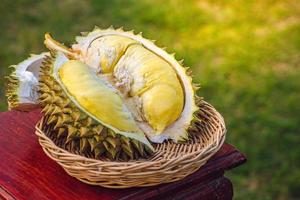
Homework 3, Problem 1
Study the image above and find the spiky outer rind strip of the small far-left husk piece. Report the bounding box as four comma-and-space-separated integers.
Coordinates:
5, 68, 20, 109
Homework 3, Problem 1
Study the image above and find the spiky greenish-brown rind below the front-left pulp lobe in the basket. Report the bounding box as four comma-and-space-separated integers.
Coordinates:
39, 52, 152, 160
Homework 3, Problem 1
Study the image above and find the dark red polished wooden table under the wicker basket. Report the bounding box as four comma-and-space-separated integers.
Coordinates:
0, 109, 246, 200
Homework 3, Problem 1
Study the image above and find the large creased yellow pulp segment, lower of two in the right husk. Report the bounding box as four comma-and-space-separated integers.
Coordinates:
114, 44, 184, 135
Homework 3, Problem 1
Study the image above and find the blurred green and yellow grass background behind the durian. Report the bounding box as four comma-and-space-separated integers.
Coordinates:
0, 0, 300, 200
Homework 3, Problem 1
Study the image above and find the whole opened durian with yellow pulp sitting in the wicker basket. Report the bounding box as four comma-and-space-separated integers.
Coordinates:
5, 28, 200, 160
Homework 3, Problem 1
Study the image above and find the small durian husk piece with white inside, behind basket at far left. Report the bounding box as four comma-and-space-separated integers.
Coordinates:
6, 53, 49, 110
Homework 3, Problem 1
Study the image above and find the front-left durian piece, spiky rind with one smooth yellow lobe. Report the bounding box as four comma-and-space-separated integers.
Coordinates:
39, 52, 154, 160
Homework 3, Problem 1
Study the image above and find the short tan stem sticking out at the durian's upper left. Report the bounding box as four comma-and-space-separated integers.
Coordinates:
44, 33, 79, 58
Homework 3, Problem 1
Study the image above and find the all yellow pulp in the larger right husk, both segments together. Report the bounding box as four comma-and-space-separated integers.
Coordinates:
85, 35, 184, 135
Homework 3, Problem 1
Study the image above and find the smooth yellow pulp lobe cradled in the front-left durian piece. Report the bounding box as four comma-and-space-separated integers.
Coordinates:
55, 55, 153, 150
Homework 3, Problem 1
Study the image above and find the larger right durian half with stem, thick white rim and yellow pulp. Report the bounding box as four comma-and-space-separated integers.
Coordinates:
45, 27, 200, 143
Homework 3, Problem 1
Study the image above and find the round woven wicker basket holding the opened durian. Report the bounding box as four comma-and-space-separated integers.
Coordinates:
36, 101, 226, 188
